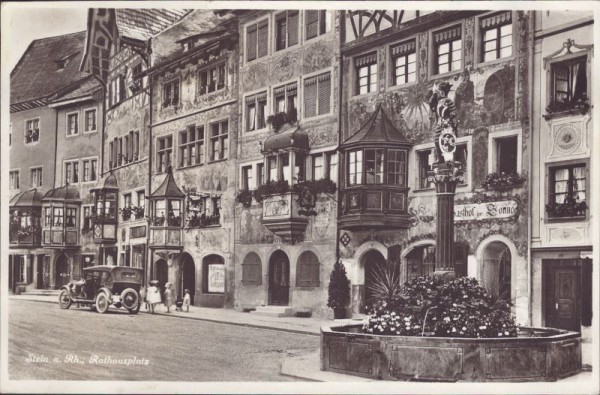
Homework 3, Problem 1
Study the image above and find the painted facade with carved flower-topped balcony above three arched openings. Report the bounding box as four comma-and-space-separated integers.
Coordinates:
234, 10, 339, 316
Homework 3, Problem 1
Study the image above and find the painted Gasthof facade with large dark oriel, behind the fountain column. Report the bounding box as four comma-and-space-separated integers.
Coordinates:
338, 11, 531, 323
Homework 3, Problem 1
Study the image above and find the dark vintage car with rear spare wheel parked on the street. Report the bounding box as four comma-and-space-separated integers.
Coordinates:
58, 265, 143, 314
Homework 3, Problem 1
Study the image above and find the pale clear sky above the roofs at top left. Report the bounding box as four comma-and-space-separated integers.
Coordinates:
2, 3, 87, 71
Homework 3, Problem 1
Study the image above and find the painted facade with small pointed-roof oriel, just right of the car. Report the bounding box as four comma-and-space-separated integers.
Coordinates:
147, 10, 239, 308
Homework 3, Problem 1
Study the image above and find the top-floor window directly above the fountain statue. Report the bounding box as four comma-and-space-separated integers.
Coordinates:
433, 25, 462, 74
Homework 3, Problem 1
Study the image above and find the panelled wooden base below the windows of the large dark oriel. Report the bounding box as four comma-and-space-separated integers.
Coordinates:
338, 185, 410, 230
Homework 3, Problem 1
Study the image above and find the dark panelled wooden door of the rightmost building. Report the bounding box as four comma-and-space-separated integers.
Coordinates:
545, 265, 581, 332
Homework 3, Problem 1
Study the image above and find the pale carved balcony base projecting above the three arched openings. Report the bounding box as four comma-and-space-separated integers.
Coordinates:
262, 192, 308, 244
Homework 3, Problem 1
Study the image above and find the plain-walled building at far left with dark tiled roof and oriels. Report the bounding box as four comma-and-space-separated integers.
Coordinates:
9, 32, 102, 292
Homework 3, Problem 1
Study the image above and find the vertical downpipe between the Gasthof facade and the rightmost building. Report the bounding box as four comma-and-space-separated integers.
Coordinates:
527, 10, 536, 326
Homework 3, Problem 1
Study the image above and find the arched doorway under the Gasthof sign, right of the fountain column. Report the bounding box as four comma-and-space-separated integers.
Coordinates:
481, 241, 512, 301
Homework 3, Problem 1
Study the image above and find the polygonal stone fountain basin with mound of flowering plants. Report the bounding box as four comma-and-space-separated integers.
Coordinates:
321, 276, 581, 382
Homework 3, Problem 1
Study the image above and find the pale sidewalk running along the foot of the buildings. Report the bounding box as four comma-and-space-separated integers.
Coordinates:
9, 295, 360, 336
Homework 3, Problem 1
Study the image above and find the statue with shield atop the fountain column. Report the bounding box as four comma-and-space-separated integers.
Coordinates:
428, 82, 457, 163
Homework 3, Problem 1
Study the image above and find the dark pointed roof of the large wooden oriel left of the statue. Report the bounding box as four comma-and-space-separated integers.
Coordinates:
340, 104, 412, 148
